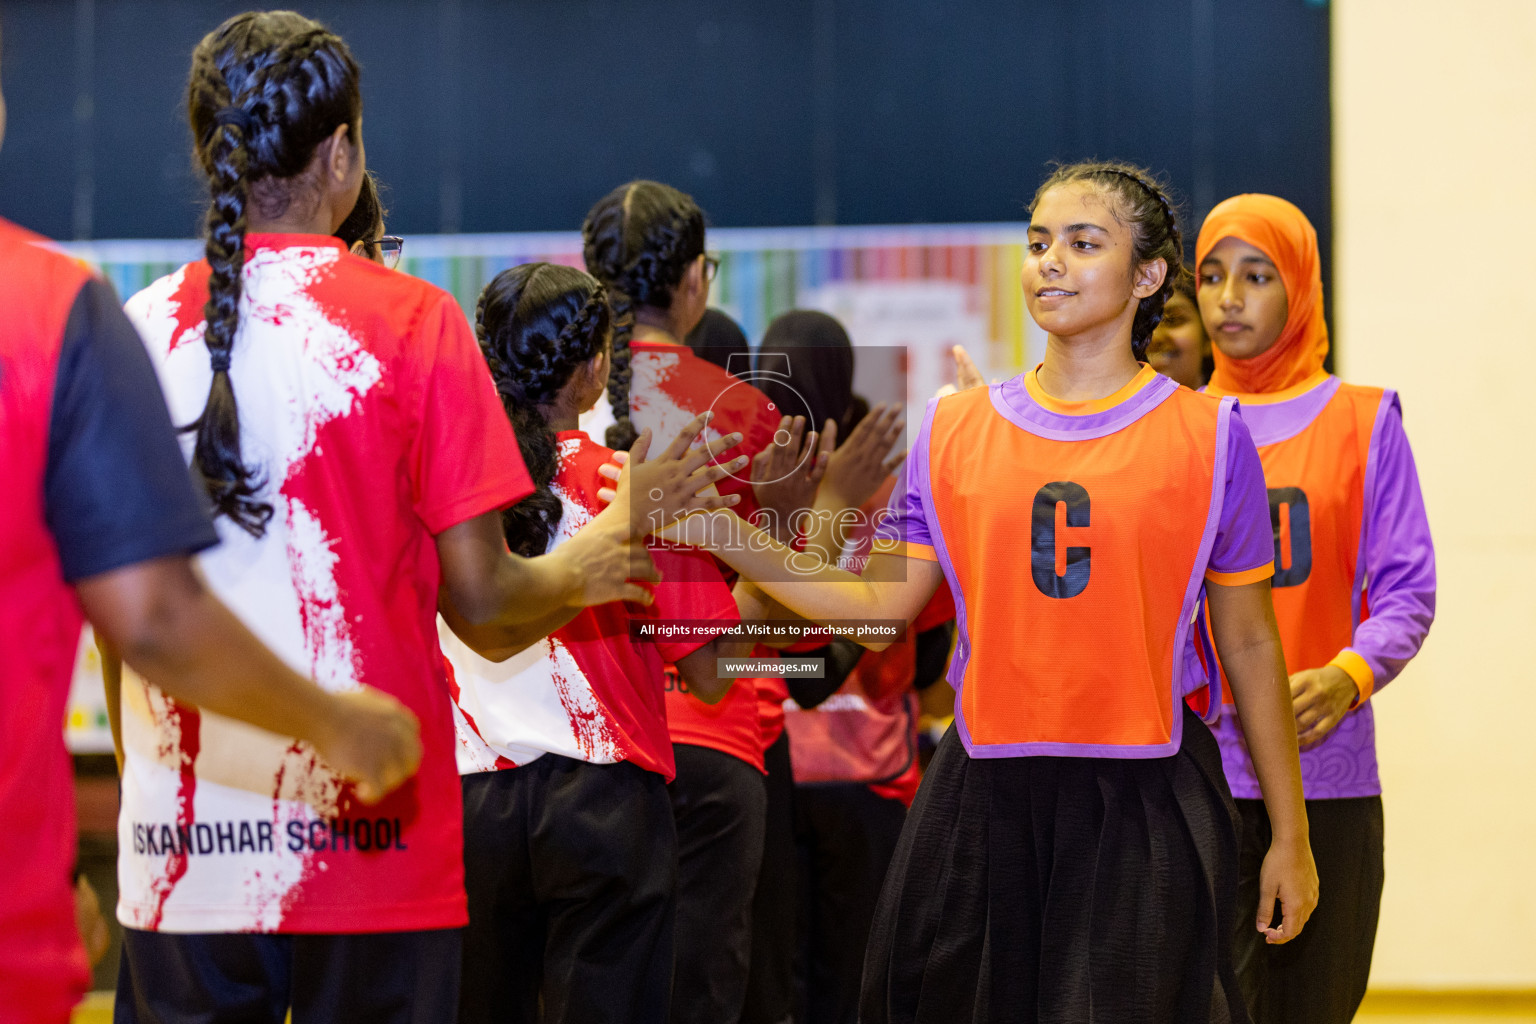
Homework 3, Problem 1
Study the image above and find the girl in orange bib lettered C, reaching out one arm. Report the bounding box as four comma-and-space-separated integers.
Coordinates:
660, 163, 1318, 1024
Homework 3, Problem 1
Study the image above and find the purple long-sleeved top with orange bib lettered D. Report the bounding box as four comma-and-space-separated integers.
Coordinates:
1217, 375, 1435, 800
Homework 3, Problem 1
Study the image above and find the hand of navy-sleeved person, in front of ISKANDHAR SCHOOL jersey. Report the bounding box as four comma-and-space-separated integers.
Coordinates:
315, 686, 421, 803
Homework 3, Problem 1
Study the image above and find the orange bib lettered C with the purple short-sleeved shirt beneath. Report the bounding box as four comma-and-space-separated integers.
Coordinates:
883, 368, 1272, 757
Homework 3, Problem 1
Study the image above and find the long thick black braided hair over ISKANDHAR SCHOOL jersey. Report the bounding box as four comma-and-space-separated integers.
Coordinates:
184, 11, 362, 537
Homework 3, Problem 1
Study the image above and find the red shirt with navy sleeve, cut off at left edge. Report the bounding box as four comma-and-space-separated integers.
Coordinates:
0, 220, 218, 1024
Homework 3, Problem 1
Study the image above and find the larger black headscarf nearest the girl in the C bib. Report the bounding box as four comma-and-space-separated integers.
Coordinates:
753, 309, 854, 434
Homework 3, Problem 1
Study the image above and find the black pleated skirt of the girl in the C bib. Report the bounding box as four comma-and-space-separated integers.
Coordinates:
860, 711, 1249, 1024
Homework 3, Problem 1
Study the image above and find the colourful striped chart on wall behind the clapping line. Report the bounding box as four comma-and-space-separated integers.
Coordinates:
63, 224, 1044, 393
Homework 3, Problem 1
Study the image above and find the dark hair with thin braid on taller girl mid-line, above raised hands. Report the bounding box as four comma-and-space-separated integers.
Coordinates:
581, 181, 703, 448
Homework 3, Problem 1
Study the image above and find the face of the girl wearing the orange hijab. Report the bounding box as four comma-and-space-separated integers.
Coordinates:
1197, 235, 1289, 359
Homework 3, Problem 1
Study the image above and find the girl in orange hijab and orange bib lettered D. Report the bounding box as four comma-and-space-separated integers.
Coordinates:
1195, 195, 1435, 1024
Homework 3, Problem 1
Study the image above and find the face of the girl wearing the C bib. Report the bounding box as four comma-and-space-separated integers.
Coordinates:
1023, 181, 1166, 338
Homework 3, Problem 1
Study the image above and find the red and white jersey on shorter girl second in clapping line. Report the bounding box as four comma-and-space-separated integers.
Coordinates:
438, 430, 740, 781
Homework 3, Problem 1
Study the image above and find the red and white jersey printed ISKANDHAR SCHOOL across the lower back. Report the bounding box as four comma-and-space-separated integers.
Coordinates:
118, 235, 533, 932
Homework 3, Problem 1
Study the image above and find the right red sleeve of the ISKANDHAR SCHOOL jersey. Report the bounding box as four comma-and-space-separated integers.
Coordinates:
410, 293, 533, 534
